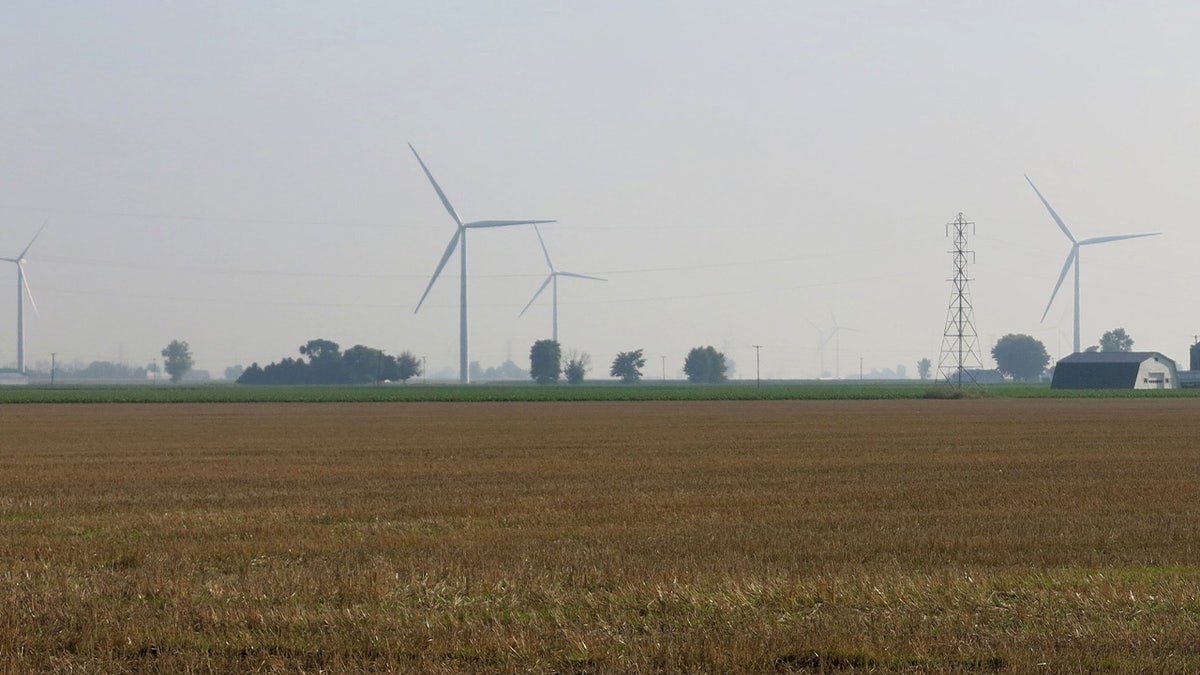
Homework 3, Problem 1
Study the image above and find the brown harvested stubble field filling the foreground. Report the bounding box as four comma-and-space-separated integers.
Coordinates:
0, 399, 1200, 673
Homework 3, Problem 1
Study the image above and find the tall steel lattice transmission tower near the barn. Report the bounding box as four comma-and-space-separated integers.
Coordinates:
937, 213, 983, 388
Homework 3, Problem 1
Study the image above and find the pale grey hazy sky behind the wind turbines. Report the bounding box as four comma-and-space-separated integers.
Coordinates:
0, 0, 1200, 377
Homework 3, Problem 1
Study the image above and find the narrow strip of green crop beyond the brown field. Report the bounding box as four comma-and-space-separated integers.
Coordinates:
7, 381, 1200, 405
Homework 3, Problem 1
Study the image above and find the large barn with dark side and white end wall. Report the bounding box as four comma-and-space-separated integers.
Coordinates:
1050, 352, 1180, 389
